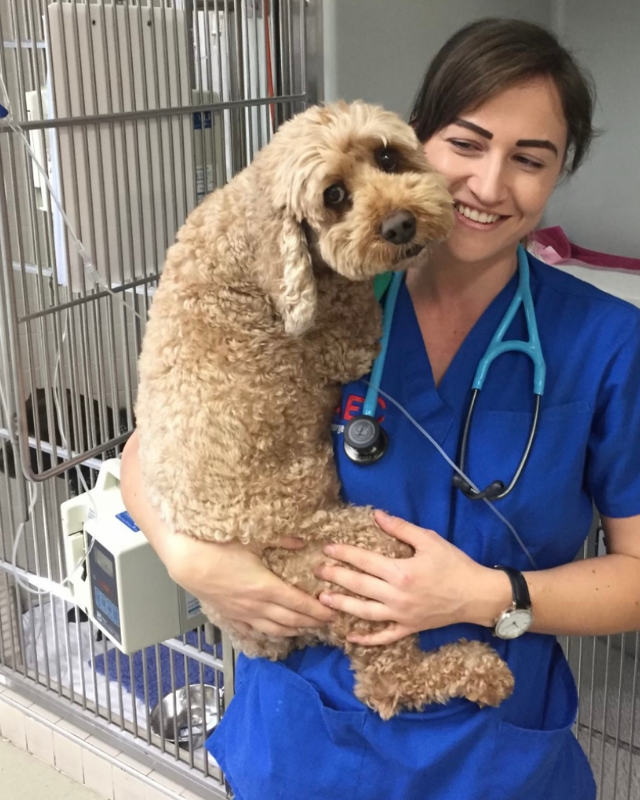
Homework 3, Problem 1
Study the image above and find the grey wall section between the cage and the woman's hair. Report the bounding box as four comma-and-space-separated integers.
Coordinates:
323, 0, 552, 117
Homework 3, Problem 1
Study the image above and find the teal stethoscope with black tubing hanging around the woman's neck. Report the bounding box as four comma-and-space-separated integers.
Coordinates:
344, 245, 546, 500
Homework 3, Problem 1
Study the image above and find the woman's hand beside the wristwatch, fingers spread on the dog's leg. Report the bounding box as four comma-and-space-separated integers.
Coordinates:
316, 511, 511, 645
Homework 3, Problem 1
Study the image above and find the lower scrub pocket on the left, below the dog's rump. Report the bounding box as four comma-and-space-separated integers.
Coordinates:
207, 659, 367, 800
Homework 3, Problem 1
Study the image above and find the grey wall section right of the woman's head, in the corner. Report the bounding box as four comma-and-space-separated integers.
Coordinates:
545, 0, 640, 258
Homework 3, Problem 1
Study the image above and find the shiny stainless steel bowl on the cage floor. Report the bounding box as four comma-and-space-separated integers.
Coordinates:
151, 683, 222, 749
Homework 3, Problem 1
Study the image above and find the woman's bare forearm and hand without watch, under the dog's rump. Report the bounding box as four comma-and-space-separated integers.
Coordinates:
120, 433, 334, 636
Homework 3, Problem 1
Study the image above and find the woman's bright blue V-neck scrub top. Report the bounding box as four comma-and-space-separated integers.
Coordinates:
207, 257, 640, 800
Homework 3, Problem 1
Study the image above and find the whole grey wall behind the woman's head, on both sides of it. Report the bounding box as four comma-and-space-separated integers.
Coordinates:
323, 0, 640, 257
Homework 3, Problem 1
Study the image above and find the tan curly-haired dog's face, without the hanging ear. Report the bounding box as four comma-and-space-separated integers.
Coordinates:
272, 102, 453, 280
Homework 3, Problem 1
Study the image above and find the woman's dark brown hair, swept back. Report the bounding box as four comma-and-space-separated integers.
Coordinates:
409, 19, 595, 174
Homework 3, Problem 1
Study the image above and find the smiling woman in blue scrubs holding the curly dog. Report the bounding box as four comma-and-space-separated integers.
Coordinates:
122, 15, 640, 800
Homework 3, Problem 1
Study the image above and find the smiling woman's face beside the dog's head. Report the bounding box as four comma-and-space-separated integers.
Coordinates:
424, 79, 567, 262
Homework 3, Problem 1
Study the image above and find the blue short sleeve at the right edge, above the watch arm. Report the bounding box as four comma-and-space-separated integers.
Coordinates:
586, 319, 640, 517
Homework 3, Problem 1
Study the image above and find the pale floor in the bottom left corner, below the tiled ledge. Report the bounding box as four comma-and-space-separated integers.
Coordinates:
0, 738, 100, 800
